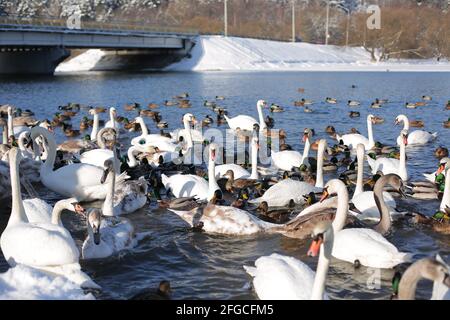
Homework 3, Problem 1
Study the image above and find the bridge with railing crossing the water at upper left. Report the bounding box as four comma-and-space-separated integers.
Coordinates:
0, 17, 196, 74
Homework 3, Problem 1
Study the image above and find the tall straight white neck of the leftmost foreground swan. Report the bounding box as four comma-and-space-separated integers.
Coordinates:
7, 149, 28, 227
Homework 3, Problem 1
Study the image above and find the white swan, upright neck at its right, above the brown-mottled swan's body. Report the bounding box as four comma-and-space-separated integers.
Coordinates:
161, 143, 220, 200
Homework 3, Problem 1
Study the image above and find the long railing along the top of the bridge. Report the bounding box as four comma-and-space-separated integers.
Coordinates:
0, 16, 199, 35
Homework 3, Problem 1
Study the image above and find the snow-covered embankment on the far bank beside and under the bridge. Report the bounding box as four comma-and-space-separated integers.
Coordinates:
56, 36, 450, 72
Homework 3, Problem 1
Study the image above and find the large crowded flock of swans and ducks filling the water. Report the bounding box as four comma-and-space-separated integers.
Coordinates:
0, 94, 450, 299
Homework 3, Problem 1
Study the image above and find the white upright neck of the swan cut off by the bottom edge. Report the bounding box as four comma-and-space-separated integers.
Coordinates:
311, 228, 334, 300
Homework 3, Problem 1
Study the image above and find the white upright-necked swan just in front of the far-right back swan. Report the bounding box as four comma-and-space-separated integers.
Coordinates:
367, 130, 409, 181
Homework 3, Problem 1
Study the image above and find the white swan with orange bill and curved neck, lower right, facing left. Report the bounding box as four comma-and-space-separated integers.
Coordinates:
322, 179, 411, 269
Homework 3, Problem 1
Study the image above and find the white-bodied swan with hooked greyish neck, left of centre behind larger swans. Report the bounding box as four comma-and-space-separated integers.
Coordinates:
80, 128, 120, 172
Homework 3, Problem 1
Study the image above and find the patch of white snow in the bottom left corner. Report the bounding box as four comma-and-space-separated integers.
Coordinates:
0, 265, 95, 300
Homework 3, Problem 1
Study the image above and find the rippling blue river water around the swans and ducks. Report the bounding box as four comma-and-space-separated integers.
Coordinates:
0, 72, 450, 299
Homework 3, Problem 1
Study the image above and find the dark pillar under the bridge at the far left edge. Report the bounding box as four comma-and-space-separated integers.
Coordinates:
0, 47, 70, 75
